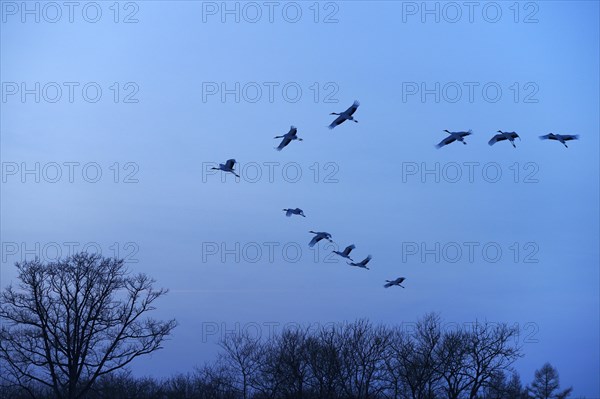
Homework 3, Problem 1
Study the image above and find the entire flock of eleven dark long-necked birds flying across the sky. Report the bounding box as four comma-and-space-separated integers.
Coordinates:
211, 101, 579, 288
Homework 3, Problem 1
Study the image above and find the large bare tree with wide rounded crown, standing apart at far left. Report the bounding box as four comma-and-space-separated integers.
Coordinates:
0, 253, 176, 399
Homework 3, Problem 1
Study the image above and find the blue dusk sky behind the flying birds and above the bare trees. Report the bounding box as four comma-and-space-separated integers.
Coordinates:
0, 1, 600, 397
